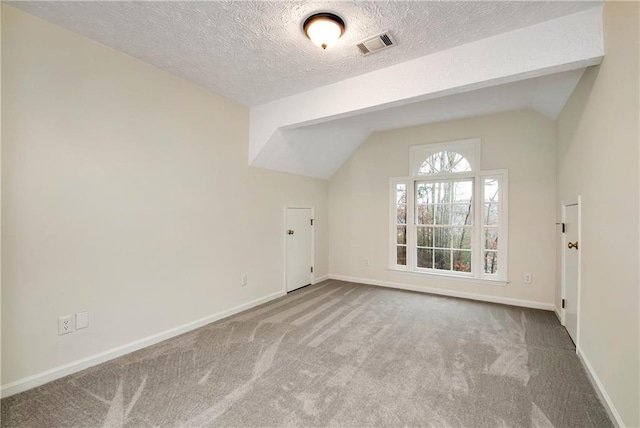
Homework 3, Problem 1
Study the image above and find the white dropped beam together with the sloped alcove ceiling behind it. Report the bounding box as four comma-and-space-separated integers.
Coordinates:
249, 7, 604, 179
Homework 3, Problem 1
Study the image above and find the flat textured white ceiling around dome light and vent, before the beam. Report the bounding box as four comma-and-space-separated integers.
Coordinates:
10, 1, 601, 106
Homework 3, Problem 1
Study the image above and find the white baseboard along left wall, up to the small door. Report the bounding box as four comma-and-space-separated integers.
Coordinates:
1, 290, 286, 398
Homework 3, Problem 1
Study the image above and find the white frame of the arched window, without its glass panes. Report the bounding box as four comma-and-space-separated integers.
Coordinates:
389, 138, 509, 285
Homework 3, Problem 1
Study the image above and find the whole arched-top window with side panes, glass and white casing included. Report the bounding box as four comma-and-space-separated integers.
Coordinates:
389, 139, 508, 283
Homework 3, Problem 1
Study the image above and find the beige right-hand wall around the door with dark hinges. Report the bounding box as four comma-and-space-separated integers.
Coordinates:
556, 2, 640, 426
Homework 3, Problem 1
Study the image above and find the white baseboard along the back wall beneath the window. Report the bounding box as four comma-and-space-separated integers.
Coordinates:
329, 275, 554, 311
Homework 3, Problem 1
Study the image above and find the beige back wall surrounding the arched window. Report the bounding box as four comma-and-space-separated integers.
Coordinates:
329, 110, 556, 305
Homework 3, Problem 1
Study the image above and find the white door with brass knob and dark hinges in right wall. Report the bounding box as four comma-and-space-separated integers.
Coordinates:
562, 204, 580, 345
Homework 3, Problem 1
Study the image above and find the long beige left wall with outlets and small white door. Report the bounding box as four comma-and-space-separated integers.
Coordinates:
2, 5, 328, 384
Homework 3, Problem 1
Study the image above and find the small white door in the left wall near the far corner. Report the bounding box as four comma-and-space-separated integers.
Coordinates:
285, 208, 313, 291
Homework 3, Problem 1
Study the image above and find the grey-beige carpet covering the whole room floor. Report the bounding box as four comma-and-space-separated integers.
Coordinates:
1, 281, 612, 427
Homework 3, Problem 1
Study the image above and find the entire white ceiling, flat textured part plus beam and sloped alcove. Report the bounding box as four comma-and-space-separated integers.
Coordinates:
10, 0, 604, 178
